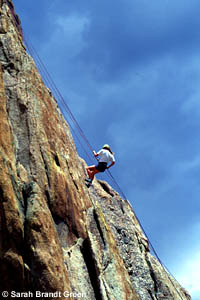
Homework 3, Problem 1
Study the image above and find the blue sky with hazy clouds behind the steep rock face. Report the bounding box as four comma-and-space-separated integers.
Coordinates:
13, 0, 200, 300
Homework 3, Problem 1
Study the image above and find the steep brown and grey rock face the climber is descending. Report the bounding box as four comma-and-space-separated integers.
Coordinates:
0, 0, 191, 300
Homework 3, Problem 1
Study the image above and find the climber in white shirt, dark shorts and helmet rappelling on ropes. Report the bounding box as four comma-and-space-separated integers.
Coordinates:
86, 144, 115, 187
